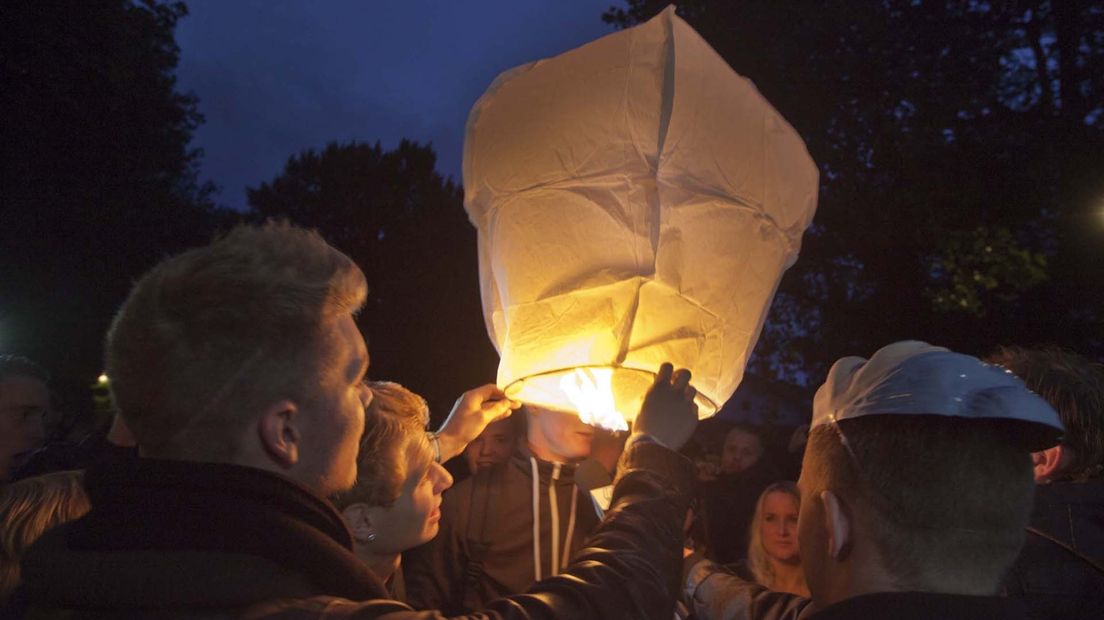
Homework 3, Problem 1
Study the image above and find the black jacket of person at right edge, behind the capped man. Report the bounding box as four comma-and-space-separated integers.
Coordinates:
1005, 480, 1104, 619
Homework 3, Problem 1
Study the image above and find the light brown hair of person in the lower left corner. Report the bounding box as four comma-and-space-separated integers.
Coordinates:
0, 471, 91, 607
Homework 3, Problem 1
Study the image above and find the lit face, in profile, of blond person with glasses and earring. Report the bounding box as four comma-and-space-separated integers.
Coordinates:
367, 450, 453, 554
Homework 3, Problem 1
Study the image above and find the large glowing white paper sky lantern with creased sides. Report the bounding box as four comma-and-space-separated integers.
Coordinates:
464, 8, 817, 428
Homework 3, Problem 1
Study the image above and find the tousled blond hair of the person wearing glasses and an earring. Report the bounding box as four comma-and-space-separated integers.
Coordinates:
333, 382, 433, 507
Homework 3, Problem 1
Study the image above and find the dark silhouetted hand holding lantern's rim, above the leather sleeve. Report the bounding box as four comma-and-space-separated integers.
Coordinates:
633, 363, 698, 450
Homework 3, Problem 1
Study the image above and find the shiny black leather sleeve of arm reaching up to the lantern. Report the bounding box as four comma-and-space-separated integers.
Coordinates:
246, 436, 693, 620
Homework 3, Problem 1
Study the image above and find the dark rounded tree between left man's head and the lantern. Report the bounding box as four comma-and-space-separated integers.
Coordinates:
247, 140, 498, 420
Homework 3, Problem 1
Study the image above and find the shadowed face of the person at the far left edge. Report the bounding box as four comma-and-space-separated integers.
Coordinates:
0, 375, 50, 481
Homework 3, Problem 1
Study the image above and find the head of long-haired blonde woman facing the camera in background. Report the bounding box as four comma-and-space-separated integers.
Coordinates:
747, 482, 809, 597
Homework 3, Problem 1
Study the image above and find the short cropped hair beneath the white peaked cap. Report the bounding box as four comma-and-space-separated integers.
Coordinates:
802, 415, 1034, 592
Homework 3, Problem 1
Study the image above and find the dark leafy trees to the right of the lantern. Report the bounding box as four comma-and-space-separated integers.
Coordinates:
603, 0, 1104, 381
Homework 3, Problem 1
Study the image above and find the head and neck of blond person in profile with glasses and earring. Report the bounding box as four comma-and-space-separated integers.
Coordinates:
333, 382, 453, 600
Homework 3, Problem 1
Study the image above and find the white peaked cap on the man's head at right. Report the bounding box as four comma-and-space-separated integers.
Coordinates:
813, 341, 1063, 450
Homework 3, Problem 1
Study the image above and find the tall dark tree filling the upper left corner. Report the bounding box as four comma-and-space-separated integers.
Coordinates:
0, 0, 226, 430
